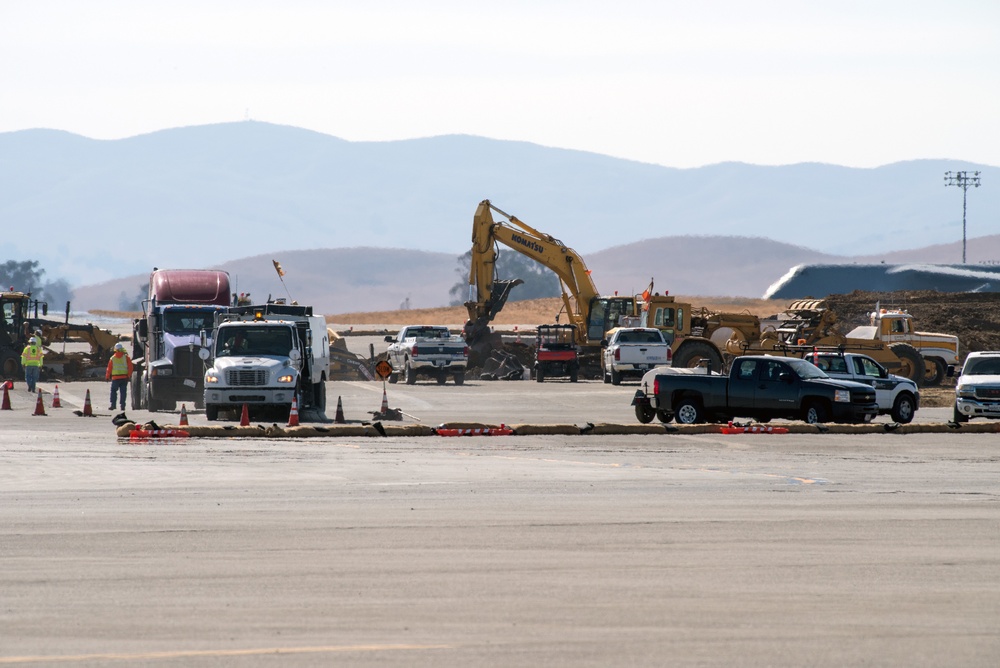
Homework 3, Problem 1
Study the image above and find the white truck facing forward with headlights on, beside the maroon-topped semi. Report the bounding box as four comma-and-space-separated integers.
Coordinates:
203, 303, 330, 420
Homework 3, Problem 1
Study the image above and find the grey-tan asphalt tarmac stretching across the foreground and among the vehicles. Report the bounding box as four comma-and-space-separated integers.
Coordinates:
0, 381, 1000, 666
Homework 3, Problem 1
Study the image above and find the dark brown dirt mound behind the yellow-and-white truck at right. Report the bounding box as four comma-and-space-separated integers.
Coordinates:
826, 290, 1000, 360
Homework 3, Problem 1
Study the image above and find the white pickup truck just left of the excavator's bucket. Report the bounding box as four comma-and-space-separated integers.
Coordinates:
385, 325, 469, 385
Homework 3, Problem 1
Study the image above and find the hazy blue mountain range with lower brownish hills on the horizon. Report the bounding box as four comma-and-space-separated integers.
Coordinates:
0, 121, 1000, 310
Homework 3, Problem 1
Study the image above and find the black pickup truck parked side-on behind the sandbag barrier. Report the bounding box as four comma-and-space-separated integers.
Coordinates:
632, 355, 879, 424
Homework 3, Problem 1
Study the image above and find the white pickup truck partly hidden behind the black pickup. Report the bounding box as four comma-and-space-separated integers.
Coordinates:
805, 352, 920, 424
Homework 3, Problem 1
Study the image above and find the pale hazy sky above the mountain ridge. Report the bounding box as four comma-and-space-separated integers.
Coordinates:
0, 0, 1000, 167
